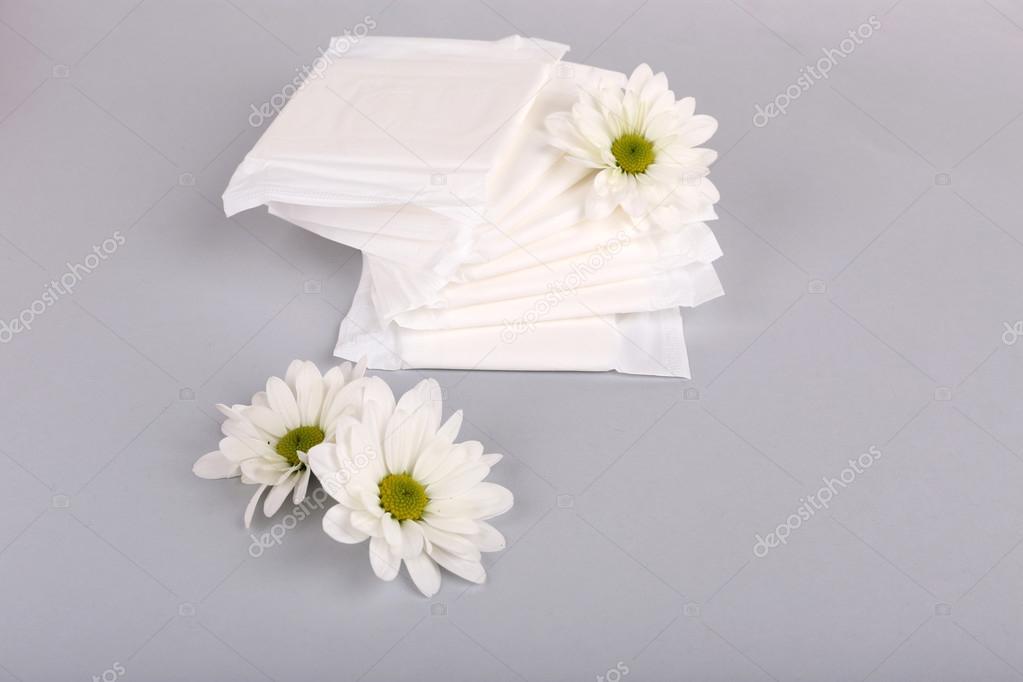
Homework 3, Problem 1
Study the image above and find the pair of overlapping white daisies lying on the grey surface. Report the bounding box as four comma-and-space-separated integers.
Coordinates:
192, 360, 514, 596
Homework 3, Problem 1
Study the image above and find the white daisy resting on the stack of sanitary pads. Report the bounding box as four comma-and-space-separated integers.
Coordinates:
545, 64, 719, 226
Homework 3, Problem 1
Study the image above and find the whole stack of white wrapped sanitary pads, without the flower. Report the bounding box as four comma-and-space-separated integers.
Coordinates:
224, 37, 723, 377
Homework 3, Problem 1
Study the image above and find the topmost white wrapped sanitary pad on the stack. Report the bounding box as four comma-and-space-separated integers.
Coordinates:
224, 36, 568, 215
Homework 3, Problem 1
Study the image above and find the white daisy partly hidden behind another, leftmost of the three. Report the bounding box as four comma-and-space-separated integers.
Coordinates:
192, 360, 370, 528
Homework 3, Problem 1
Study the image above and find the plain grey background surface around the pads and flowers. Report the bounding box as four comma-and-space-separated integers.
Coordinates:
0, 0, 1023, 682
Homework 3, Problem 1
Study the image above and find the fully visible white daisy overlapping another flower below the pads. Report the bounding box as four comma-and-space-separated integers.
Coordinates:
309, 379, 513, 596
